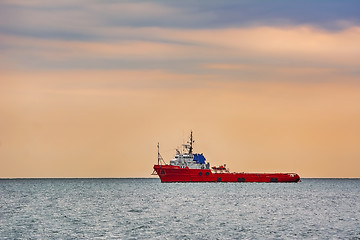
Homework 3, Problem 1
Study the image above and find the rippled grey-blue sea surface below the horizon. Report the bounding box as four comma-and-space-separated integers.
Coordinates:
0, 179, 360, 239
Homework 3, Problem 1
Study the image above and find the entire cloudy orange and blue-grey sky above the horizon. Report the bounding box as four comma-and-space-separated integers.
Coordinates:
0, 0, 360, 178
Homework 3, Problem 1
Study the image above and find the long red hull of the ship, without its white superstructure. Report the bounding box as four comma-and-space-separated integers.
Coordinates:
154, 165, 300, 182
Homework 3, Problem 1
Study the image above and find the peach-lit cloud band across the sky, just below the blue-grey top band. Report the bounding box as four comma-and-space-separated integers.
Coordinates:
0, 26, 360, 80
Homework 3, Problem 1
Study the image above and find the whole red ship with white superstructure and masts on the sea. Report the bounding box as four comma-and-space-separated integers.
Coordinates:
153, 132, 300, 182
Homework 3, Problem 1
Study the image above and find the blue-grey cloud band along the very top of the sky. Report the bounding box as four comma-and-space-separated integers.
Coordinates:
0, 0, 360, 44
